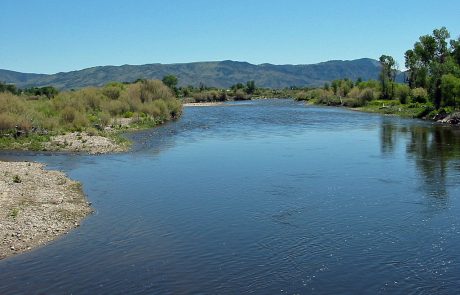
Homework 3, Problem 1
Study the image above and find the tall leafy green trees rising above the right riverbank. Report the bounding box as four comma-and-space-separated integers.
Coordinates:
380, 27, 460, 110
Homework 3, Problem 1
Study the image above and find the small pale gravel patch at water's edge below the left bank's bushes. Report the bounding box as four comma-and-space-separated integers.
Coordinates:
45, 132, 126, 154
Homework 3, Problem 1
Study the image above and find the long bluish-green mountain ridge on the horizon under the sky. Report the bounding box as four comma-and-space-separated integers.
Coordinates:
0, 58, 402, 89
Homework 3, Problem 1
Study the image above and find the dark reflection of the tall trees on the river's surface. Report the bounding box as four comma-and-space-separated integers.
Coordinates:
380, 118, 460, 205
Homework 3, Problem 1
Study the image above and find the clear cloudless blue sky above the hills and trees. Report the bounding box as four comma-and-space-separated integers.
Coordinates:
0, 0, 460, 73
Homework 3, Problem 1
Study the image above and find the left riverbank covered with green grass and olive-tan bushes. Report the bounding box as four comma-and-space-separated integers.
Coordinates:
0, 80, 182, 150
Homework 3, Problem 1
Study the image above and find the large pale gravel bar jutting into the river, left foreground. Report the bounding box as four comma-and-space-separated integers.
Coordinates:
0, 161, 91, 259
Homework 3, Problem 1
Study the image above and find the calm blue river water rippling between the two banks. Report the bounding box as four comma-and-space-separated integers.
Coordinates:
0, 100, 460, 294
